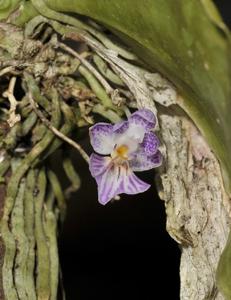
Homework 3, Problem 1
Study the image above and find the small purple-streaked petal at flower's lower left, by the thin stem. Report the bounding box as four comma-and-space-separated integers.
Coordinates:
89, 153, 111, 177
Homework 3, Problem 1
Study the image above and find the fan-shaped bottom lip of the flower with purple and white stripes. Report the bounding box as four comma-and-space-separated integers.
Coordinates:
96, 164, 150, 205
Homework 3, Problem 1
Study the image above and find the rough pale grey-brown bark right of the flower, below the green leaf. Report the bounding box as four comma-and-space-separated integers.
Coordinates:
160, 114, 230, 300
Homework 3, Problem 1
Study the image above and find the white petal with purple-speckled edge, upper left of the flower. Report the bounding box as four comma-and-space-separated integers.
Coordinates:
89, 123, 115, 154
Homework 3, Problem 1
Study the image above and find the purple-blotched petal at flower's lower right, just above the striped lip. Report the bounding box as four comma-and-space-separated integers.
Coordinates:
129, 151, 162, 172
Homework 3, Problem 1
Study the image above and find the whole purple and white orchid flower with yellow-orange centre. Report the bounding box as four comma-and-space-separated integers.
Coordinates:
89, 109, 162, 205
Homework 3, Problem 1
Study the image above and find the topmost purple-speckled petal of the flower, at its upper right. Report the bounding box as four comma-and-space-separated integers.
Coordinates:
128, 109, 156, 131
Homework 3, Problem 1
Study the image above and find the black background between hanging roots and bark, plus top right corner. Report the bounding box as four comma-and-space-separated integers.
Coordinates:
60, 0, 231, 300
